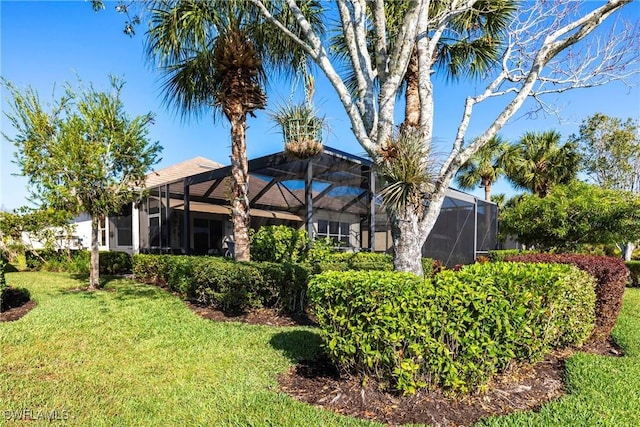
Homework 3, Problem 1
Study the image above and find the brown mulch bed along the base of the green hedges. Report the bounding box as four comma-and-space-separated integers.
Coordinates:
186, 302, 622, 426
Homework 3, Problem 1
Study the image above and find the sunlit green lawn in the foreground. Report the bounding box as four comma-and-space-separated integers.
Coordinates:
0, 273, 640, 426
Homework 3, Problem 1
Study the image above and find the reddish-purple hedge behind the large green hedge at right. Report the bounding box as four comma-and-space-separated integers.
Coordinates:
505, 254, 628, 341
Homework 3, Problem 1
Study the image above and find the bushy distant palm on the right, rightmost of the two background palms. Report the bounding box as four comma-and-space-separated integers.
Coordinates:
503, 131, 581, 197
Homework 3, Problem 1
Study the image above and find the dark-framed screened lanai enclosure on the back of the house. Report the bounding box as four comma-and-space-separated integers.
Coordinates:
138, 147, 497, 266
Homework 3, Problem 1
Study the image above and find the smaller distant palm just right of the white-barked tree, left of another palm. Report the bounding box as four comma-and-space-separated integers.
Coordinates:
456, 136, 507, 201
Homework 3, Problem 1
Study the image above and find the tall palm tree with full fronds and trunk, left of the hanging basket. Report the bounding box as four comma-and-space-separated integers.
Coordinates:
147, 0, 323, 261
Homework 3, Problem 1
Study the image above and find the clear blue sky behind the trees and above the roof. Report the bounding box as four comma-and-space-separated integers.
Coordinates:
0, 0, 640, 210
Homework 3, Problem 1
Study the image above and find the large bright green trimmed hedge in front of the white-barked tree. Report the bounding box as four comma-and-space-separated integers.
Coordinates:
309, 263, 595, 394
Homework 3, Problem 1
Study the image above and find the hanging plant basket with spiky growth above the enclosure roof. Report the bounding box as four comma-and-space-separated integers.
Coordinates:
273, 104, 325, 159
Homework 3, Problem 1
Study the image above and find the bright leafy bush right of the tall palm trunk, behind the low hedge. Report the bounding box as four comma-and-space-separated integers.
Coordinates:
251, 225, 310, 262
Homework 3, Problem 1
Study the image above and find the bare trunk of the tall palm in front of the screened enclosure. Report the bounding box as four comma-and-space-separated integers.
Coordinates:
227, 108, 251, 261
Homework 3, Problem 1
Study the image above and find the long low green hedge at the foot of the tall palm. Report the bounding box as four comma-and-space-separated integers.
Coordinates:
133, 255, 309, 313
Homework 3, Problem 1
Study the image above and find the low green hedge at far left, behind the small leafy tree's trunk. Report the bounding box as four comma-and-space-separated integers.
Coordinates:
25, 250, 131, 275
